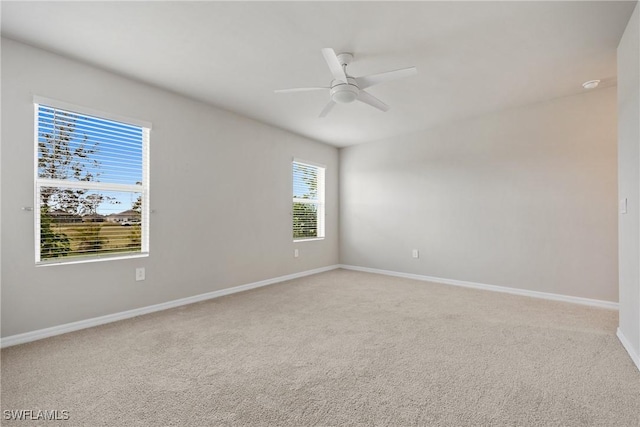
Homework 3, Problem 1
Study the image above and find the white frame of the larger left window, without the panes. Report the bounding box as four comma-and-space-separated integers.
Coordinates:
33, 96, 152, 266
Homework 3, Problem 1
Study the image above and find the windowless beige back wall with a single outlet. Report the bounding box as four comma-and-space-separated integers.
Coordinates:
340, 86, 618, 302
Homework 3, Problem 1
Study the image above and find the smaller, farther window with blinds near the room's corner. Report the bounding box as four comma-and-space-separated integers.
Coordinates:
293, 160, 325, 240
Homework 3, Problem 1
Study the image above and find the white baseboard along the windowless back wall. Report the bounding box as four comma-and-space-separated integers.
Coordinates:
340, 264, 618, 310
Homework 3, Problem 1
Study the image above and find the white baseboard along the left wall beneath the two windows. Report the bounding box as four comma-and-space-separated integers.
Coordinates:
0, 265, 340, 348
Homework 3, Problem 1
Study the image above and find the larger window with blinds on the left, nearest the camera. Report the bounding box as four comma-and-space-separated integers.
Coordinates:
35, 101, 150, 263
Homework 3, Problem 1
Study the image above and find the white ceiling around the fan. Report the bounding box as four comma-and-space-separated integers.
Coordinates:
2, 1, 635, 146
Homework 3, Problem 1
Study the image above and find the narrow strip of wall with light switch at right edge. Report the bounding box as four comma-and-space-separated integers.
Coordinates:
618, 6, 640, 367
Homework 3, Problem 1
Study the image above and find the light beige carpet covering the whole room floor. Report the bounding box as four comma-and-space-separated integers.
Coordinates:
1, 270, 640, 427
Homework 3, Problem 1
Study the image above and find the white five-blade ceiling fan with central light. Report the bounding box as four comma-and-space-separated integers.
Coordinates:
275, 48, 418, 117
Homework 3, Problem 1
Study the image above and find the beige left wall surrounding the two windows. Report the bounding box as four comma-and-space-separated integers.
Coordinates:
1, 39, 338, 337
